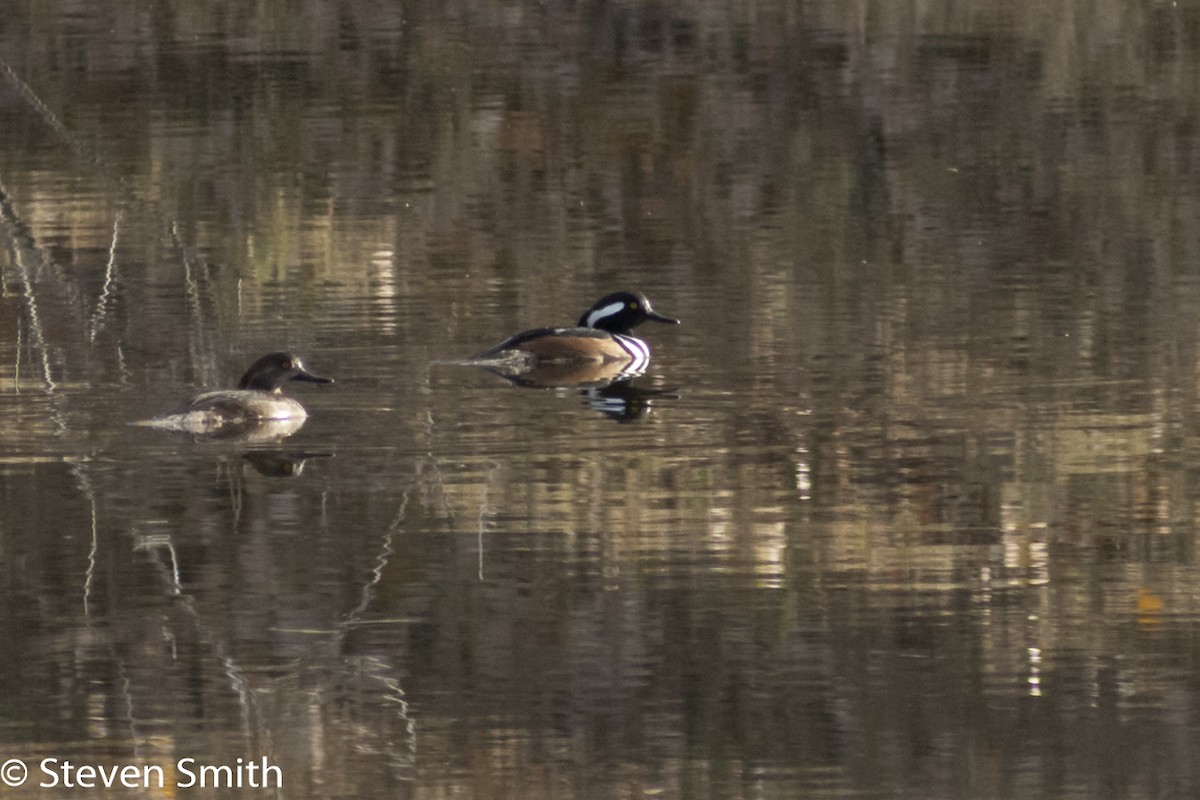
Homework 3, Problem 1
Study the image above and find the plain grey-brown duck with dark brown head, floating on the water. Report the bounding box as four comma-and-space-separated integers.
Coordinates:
134, 353, 334, 440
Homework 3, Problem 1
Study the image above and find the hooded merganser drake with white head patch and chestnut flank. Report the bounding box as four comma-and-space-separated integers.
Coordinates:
475, 291, 679, 383
